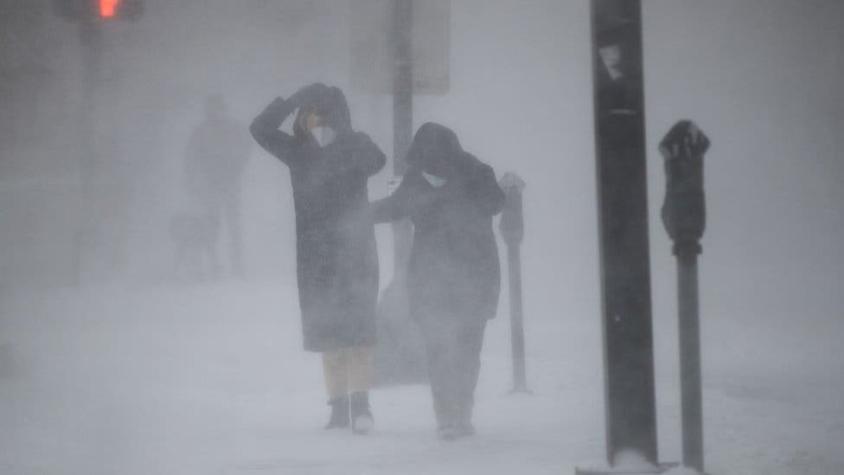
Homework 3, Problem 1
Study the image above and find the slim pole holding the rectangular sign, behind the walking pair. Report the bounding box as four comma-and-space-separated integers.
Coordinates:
392, 0, 413, 285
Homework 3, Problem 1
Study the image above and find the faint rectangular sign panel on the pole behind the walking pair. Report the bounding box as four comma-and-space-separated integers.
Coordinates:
350, 0, 451, 95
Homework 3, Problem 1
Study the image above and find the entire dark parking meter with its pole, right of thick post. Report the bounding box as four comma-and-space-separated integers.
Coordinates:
659, 120, 710, 472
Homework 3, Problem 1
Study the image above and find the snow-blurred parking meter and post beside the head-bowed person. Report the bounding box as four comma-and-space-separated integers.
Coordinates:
499, 173, 530, 393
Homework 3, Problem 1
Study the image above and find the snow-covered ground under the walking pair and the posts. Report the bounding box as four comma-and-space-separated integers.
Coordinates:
0, 283, 844, 475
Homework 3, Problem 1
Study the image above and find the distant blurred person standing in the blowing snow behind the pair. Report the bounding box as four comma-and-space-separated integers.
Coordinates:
185, 95, 251, 275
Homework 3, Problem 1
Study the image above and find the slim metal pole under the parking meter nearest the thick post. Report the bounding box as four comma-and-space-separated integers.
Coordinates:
677, 253, 703, 473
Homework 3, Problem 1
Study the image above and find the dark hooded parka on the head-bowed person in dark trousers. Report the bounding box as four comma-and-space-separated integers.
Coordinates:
373, 123, 504, 321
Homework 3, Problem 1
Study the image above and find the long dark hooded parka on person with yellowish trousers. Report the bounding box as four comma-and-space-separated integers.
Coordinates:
250, 84, 386, 351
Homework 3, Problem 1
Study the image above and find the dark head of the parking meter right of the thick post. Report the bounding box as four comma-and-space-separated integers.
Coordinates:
659, 120, 709, 256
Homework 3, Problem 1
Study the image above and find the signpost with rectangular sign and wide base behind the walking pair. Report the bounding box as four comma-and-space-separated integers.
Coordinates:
351, 0, 451, 384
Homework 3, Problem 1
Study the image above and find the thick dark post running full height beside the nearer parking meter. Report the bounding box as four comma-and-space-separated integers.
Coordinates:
592, 0, 657, 466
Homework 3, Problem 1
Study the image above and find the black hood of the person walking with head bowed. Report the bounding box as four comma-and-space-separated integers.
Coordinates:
407, 122, 467, 176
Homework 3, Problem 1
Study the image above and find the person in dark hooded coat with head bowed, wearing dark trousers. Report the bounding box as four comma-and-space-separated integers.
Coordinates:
373, 123, 504, 440
